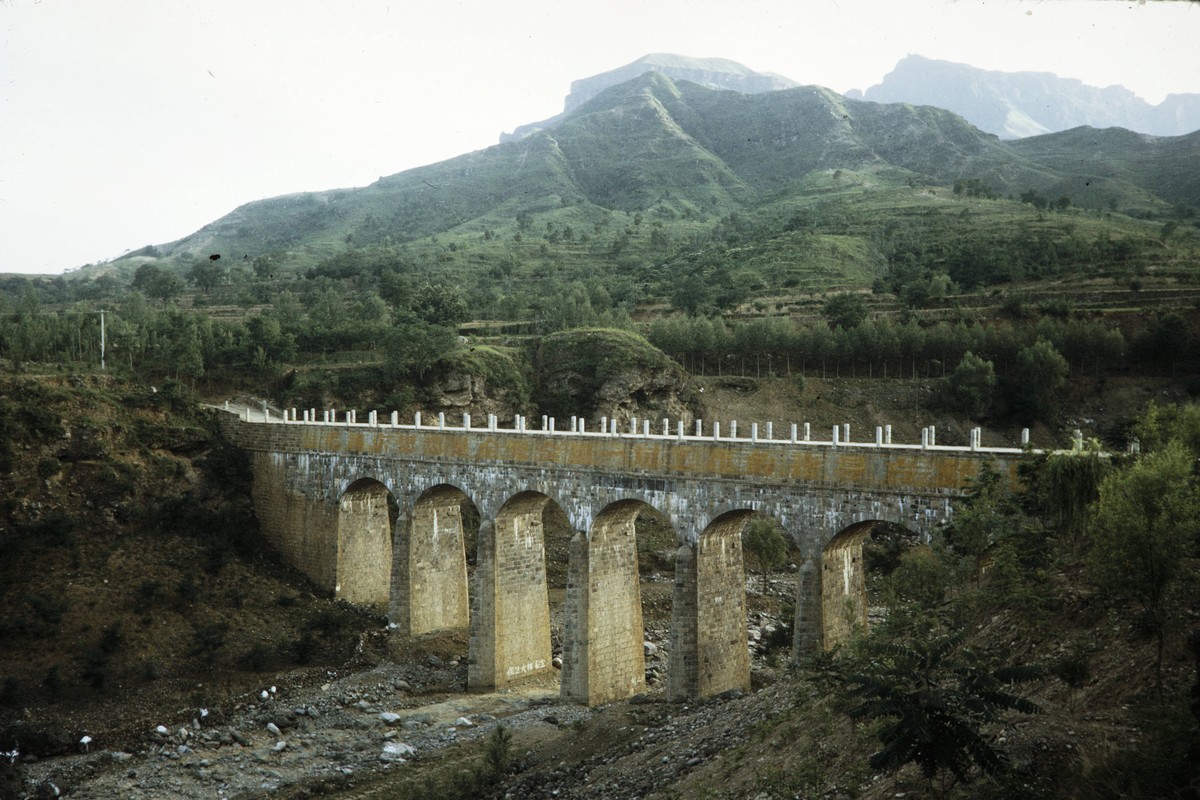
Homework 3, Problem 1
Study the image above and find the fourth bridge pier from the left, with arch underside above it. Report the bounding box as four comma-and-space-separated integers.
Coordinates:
562, 499, 678, 705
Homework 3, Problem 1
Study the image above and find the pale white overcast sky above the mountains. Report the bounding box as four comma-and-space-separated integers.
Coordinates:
0, 0, 1200, 272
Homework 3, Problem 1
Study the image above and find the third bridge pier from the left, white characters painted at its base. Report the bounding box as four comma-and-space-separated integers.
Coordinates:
467, 491, 562, 690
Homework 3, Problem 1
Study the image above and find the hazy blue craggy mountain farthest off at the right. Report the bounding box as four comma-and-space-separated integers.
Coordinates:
846, 55, 1200, 139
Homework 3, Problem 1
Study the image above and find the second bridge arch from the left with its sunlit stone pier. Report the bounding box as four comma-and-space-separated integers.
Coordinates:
391, 483, 479, 636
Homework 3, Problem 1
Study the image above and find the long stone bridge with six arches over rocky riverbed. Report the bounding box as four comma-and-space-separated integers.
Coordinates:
213, 411, 1022, 704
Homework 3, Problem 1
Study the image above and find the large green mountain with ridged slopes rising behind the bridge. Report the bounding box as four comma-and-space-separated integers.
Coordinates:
124, 72, 1200, 281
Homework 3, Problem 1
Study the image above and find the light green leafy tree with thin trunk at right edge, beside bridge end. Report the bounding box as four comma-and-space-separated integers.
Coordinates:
1088, 440, 1200, 688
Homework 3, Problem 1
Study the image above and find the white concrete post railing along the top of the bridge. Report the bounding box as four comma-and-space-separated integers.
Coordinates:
223, 402, 1051, 455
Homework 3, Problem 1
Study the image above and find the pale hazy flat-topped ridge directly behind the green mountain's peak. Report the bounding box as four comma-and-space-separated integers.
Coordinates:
500, 53, 799, 144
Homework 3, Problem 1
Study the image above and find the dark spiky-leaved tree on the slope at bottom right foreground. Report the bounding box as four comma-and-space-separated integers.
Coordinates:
848, 634, 1040, 795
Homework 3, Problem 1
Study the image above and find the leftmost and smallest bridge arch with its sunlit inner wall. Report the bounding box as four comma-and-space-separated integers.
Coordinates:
334, 477, 400, 608
